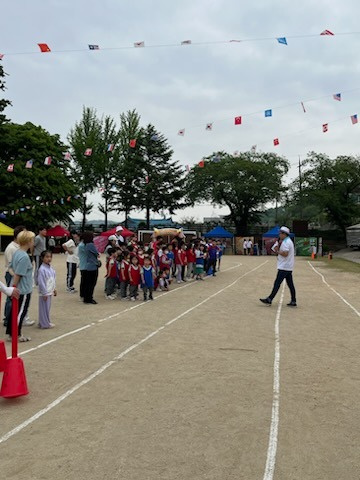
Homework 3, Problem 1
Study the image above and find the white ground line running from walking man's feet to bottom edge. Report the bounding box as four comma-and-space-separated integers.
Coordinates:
263, 283, 285, 480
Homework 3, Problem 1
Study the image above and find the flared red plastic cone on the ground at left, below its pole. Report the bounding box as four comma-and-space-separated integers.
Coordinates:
0, 357, 29, 398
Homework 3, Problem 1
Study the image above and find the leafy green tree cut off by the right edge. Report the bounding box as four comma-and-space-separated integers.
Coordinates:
297, 152, 360, 234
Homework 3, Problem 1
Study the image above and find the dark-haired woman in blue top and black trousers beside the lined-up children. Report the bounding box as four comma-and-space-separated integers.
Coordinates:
82, 232, 99, 305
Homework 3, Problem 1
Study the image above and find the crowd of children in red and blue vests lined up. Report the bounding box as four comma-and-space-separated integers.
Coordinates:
105, 235, 224, 301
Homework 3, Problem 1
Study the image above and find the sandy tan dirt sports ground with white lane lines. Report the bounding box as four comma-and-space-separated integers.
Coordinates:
0, 256, 360, 480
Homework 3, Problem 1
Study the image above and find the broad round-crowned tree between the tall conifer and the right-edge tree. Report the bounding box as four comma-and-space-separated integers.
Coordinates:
186, 152, 289, 235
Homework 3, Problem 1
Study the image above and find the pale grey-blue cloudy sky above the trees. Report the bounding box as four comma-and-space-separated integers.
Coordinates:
0, 0, 360, 220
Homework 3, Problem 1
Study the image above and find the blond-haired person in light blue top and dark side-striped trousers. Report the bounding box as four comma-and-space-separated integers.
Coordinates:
6, 230, 35, 342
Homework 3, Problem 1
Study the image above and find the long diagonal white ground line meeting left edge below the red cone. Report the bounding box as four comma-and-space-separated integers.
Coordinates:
0, 261, 268, 444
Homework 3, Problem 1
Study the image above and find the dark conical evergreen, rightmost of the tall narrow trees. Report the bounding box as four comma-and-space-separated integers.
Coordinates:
137, 124, 185, 229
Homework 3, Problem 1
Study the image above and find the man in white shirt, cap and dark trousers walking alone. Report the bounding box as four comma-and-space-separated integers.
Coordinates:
260, 227, 297, 307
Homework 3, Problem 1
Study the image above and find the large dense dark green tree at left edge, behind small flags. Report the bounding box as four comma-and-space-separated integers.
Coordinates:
0, 122, 80, 228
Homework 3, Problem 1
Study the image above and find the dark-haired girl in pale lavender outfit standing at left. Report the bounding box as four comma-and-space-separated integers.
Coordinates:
37, 250, 57, 328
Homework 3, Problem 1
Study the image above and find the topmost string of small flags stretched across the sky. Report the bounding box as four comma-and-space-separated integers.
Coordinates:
1, 29, 360, 56
